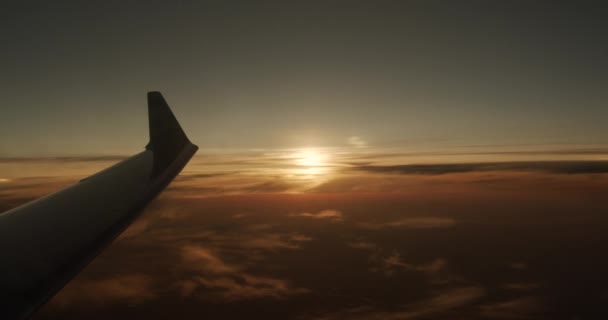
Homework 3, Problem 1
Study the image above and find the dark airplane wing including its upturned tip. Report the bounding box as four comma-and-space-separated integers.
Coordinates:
0, 92, 198, 319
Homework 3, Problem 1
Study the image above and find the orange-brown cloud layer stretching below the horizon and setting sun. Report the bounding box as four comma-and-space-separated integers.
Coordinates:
0, 155, 608, 320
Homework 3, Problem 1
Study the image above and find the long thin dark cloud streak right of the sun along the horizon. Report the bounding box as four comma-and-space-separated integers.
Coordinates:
353, 161, 608, 175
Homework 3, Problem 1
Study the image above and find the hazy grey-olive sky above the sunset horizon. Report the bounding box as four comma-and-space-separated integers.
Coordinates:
0, 1, 608, 157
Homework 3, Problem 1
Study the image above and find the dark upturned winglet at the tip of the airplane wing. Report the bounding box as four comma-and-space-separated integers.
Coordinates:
146, 91, 190, 155
